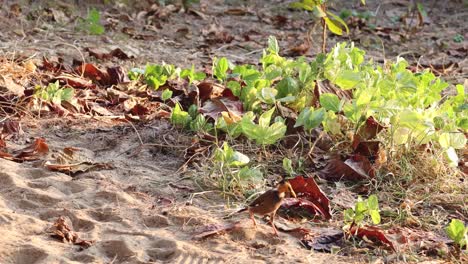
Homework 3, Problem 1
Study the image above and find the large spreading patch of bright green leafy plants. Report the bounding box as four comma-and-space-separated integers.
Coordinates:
140, 36, 468, 166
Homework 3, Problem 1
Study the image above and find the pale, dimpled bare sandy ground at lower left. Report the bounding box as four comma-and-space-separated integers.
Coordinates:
0, 120, 358, 264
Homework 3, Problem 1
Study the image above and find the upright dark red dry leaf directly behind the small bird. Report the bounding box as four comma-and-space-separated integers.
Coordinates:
284, 176, 331, 220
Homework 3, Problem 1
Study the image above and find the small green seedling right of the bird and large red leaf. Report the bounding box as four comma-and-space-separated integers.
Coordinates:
344, 195, 380, 227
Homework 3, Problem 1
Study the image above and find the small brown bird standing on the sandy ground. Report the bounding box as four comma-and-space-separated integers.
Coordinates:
238, 179, 296, 235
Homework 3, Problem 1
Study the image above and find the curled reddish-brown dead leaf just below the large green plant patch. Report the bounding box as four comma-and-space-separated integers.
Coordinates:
317, 154, 375, 181
